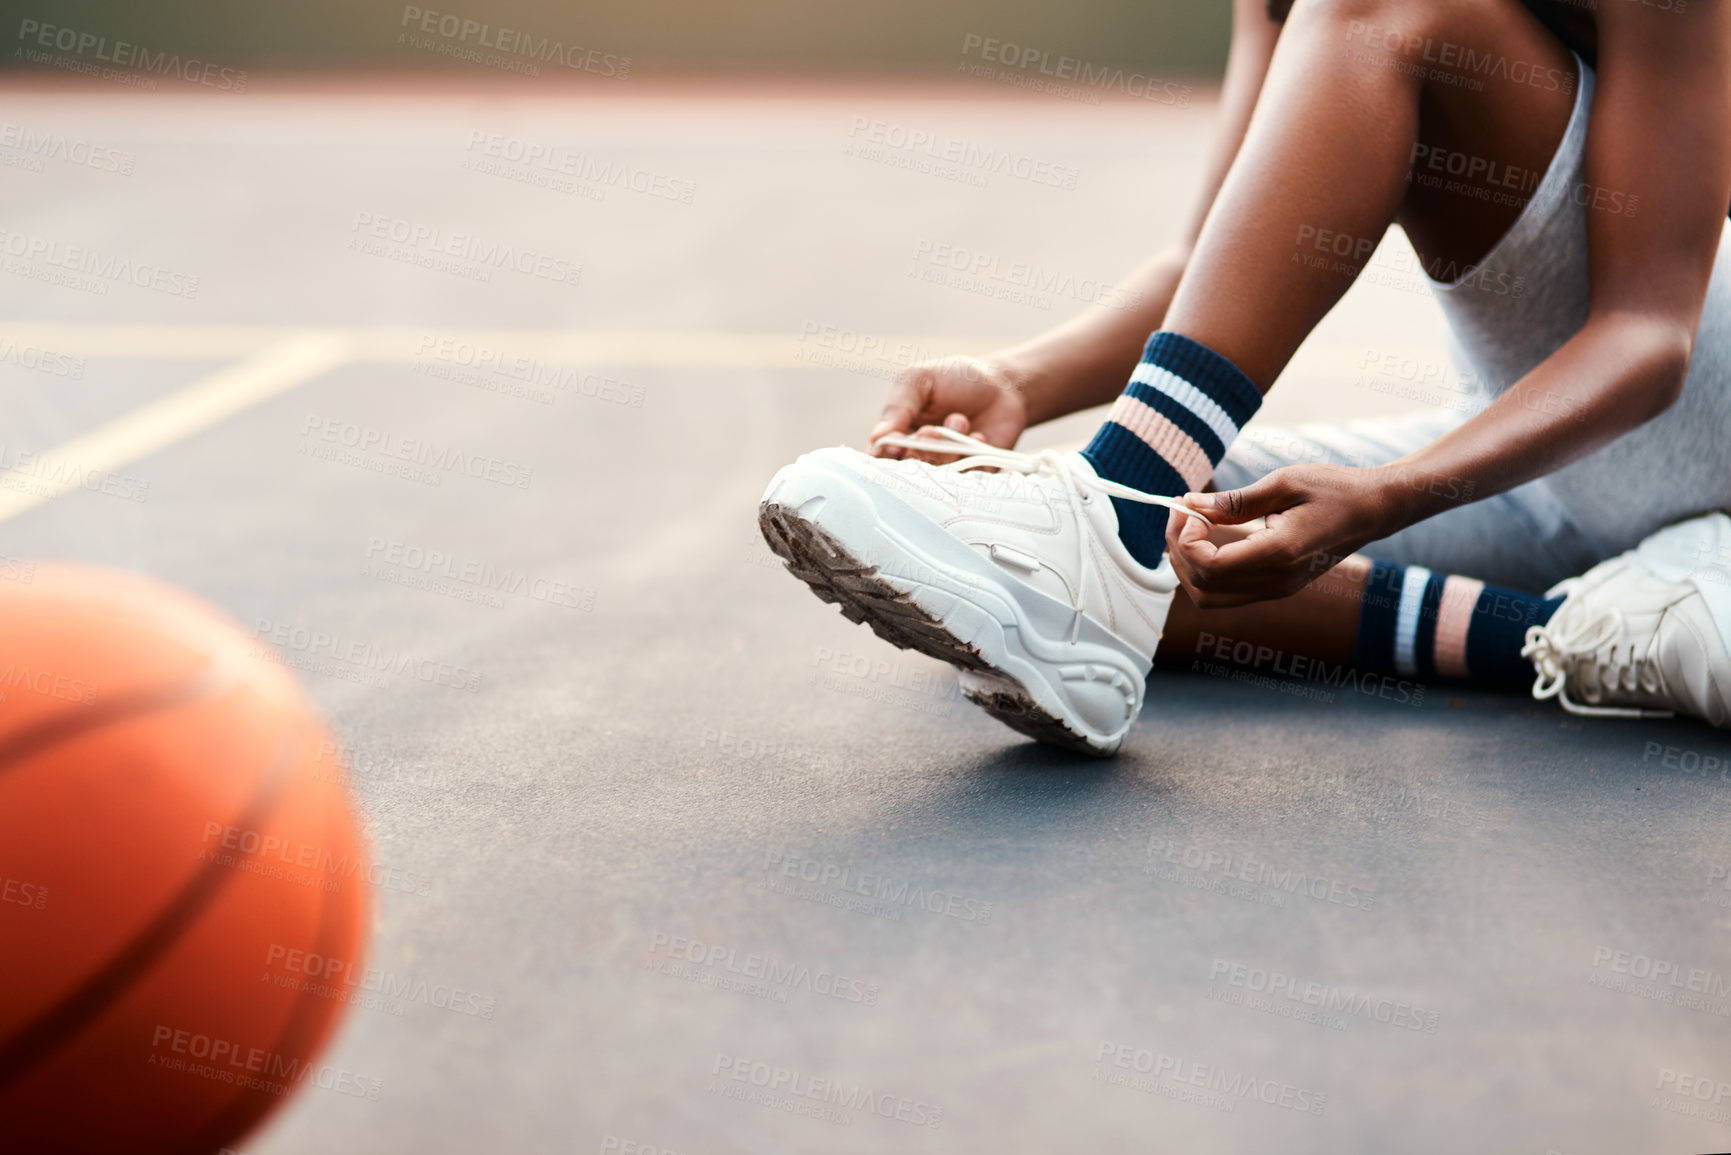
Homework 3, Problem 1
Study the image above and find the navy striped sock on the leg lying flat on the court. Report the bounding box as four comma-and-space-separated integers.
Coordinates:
1354, 561, 1563, 689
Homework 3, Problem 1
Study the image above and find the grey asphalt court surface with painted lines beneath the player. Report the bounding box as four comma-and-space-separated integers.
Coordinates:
0, 78, 1731, 1155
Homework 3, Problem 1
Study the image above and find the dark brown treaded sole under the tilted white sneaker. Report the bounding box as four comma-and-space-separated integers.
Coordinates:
758, 500, 1118, 758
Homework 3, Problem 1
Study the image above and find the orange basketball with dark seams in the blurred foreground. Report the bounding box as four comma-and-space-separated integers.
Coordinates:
0, 563, 379, 1155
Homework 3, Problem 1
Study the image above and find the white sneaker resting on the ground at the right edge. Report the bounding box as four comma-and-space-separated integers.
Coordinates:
1522, 513, 1731, 726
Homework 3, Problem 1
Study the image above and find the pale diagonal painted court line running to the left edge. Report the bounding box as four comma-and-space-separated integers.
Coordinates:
0, 332, 353, 521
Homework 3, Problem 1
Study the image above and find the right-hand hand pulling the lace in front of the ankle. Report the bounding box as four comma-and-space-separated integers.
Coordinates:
1167, 466, 1399, 610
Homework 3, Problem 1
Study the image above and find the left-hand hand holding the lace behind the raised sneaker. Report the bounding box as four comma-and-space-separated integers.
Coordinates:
871, 357, 1028, 464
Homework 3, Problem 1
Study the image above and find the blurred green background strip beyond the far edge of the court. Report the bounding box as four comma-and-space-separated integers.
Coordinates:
5, 0, 1231, 76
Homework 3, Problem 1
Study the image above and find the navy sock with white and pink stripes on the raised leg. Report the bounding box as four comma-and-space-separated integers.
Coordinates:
1082, 329, 1262, 568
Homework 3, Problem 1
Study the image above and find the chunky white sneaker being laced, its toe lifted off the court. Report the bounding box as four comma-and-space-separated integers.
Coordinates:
758, 429, 1200, 757
